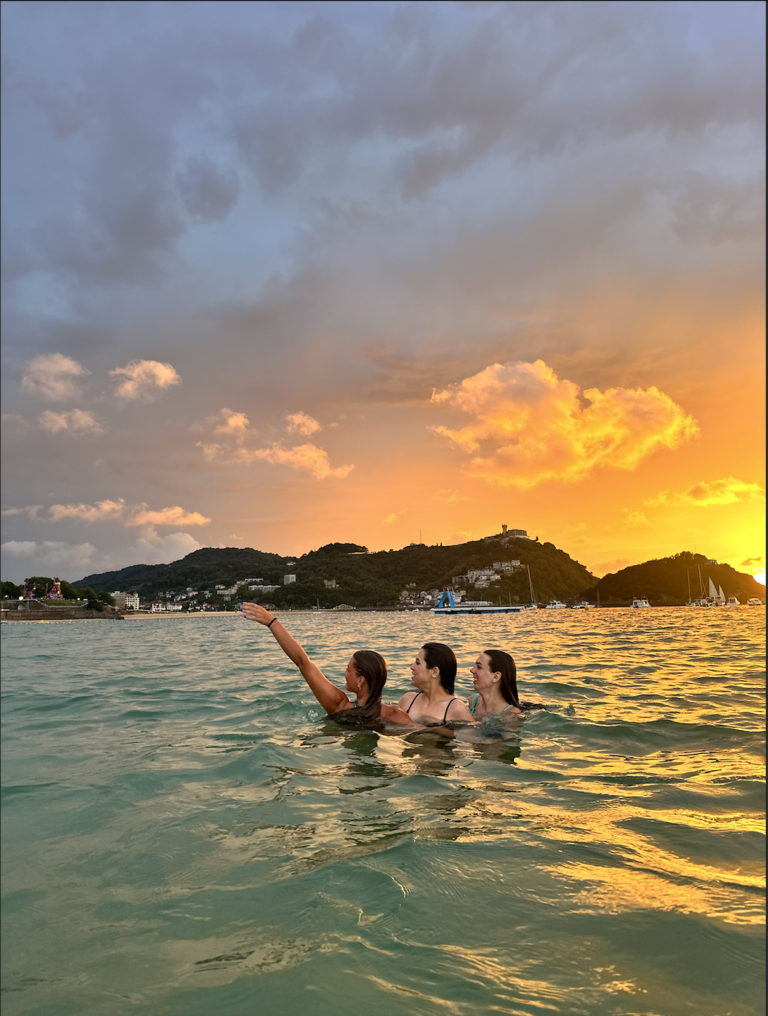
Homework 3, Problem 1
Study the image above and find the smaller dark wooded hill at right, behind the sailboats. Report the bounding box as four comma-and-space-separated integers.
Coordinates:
582, 551, 765, 605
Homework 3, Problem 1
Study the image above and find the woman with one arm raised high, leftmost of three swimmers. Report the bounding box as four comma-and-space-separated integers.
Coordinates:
238, 604, 412, 725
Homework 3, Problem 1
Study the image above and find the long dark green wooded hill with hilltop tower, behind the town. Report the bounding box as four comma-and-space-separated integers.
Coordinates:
75, 537, 594, 608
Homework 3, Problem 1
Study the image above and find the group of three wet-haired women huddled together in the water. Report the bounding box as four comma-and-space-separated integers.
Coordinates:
239, 602, 530, 726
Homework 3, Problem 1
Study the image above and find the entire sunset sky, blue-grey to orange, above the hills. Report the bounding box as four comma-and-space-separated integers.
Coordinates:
2, 0, 765, 582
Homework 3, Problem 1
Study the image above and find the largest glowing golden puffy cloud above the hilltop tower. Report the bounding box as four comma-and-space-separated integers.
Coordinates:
432, 360, 699, 488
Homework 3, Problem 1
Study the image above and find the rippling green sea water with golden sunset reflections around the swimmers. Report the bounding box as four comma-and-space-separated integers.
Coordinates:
2, 608, 765, 1016
